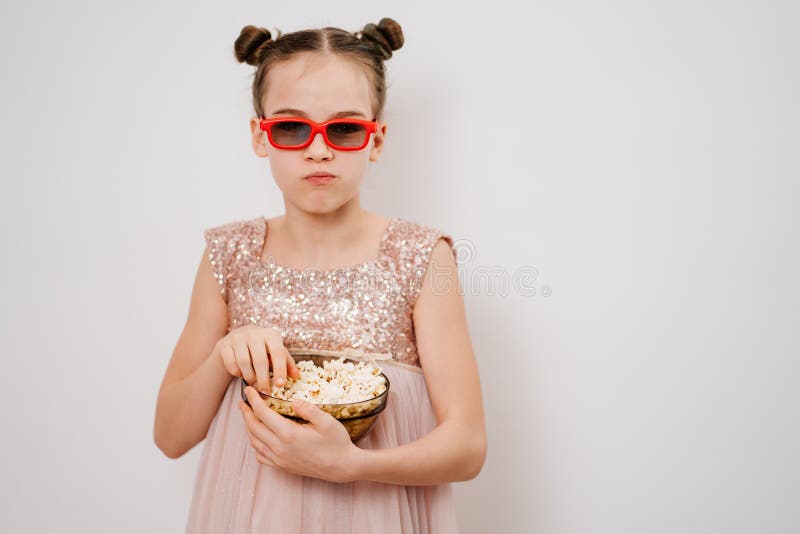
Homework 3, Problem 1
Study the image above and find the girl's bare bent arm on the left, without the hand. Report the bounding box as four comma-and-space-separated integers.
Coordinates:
153, 248, 232, 458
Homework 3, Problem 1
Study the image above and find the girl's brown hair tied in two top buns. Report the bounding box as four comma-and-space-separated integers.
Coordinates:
233, 18, 403, 119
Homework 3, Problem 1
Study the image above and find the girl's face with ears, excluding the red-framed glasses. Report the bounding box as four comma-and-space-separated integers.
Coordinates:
250, 53, 386, 213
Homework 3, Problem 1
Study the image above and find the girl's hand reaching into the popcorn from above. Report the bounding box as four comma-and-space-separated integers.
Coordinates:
212, 325, 300, 393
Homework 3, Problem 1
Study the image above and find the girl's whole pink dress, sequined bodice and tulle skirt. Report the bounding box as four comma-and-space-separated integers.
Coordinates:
186, 217, 458, 534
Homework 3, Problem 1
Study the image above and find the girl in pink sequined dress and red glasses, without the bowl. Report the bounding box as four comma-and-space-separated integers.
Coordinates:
154, 18, 486, 534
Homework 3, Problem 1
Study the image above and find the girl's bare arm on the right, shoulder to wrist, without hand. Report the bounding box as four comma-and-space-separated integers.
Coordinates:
348, 239, 487, 485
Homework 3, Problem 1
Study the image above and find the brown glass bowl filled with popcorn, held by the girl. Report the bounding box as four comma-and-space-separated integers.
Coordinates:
240, 349, 389, 443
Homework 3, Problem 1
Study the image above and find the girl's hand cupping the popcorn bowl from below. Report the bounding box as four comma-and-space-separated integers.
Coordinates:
239, 387, 361, 482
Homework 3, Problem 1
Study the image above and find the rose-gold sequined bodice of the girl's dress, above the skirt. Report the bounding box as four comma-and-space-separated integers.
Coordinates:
204, 217, 455, 367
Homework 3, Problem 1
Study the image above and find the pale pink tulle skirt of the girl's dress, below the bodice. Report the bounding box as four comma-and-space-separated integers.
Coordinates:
181, 362, 458, 534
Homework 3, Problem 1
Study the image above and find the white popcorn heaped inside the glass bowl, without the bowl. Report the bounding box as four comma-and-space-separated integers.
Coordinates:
269, 357, 386, 404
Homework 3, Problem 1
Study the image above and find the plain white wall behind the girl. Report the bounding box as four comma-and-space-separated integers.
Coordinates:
0, 1, 800, 534
